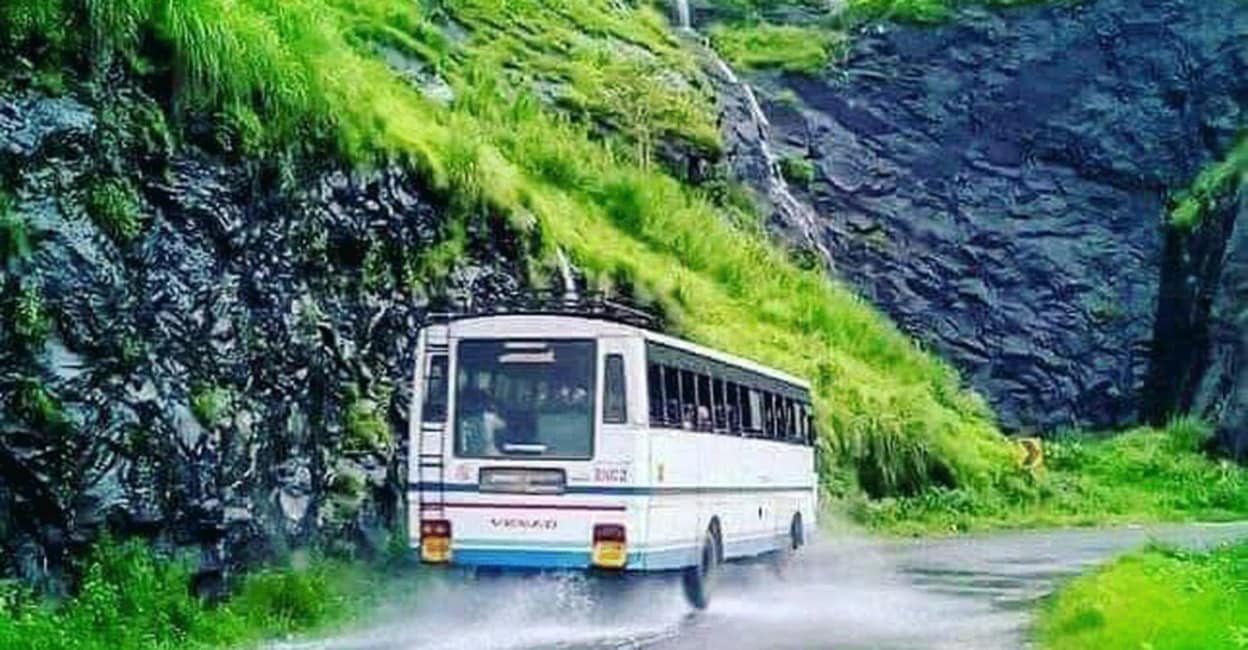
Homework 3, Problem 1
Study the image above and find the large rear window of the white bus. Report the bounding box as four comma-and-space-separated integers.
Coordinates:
454, 339, 595, 459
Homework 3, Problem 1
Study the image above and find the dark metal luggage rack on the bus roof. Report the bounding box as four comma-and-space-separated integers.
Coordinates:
428, 291, 661, 331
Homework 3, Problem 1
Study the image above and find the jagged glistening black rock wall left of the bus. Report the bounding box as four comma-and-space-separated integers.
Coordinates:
0, 81, 522, 579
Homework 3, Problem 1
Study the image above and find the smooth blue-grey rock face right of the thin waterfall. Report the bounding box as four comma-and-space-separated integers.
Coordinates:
748, 0, 1248, 430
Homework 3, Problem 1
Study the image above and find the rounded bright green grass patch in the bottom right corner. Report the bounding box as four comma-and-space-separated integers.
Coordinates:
1036, 545, 1248, 650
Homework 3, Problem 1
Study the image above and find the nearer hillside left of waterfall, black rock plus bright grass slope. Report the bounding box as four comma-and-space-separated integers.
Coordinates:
0, 0, 1013, 580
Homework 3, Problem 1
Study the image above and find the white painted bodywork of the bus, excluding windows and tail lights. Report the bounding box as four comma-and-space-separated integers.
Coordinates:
408, 316, 816, 571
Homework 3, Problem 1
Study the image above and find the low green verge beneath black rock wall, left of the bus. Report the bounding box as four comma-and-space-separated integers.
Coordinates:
0, 540, 424, 650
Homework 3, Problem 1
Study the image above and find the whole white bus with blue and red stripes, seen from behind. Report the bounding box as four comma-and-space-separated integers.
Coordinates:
408, 301, 817, 608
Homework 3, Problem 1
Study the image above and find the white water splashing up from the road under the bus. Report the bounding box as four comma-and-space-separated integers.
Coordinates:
276, 531, 1022, 650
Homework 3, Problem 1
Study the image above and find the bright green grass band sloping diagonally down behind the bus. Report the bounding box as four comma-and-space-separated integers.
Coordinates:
0, 0, 1012, 494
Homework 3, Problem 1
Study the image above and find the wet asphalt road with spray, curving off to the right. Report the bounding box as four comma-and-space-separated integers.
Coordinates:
277, 524, 1248, 650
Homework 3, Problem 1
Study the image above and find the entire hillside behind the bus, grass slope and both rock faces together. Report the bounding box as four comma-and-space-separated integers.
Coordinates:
0, 0, 1248, 608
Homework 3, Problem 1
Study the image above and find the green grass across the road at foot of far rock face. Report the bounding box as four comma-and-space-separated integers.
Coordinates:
855, 418, 1248, 534
